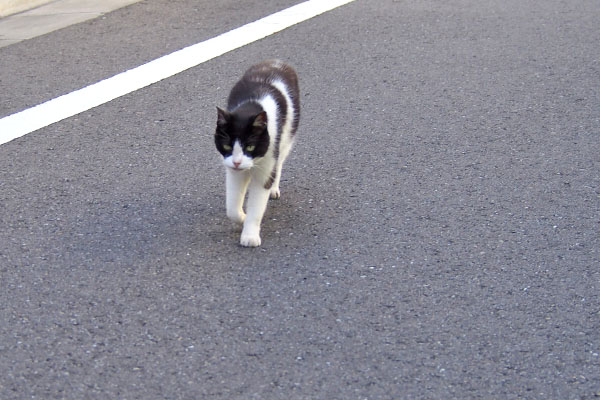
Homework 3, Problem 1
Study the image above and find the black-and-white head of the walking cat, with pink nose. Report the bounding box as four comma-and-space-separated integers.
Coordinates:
215, 107, 269, 170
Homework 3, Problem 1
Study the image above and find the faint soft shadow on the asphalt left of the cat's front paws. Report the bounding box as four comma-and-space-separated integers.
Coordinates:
62, 197, 229, 264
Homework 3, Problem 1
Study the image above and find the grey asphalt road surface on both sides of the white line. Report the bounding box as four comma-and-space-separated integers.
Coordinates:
0, 0, 600, 399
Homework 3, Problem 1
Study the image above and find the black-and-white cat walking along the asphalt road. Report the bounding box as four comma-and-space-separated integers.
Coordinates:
214, 60, 300, 247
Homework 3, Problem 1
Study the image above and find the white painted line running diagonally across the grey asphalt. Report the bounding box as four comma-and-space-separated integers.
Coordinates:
0, 0, 354, 145
